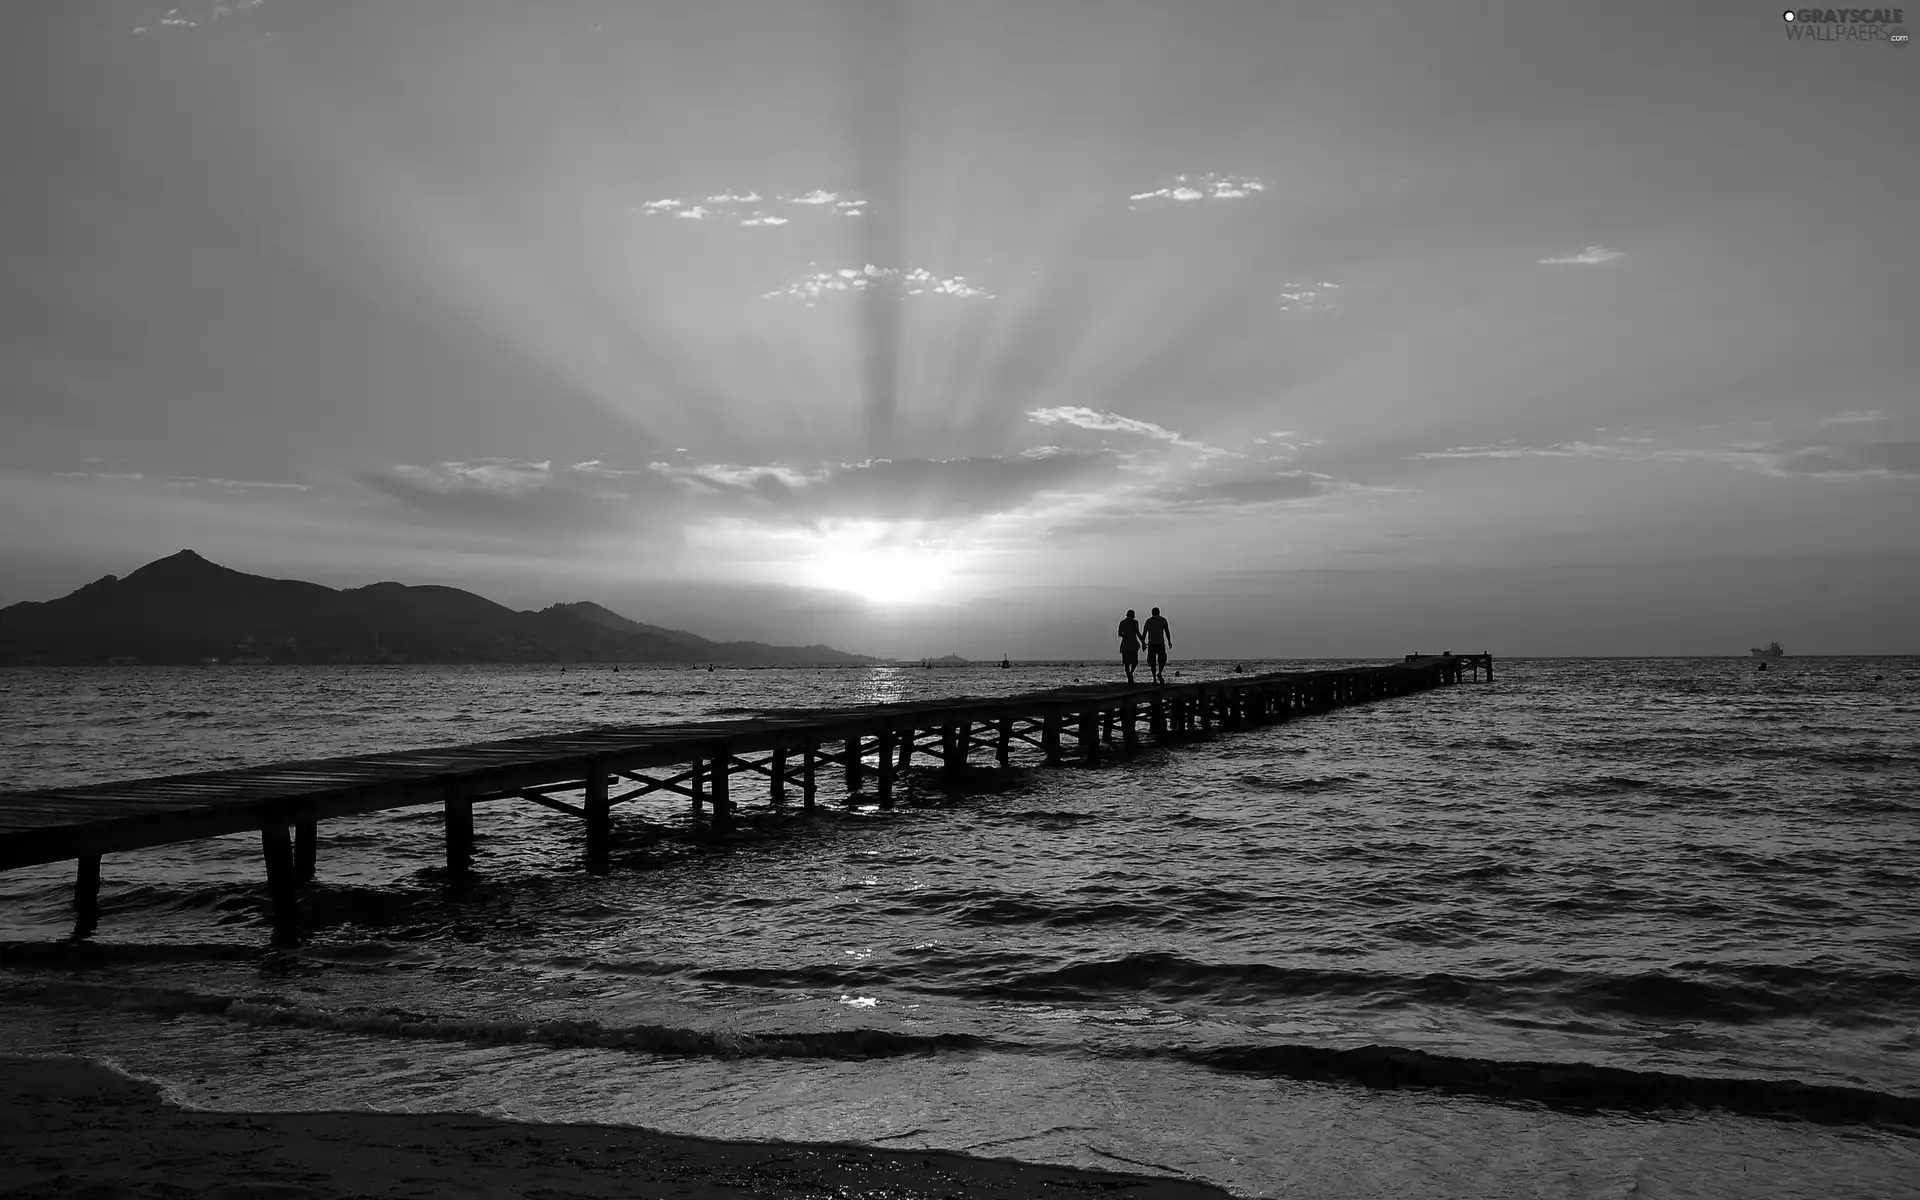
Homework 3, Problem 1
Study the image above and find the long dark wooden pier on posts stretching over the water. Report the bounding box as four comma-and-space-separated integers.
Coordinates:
0, 653, 1494, 945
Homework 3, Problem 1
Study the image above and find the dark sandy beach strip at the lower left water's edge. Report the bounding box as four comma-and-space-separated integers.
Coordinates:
0, 1058, 1227, 1200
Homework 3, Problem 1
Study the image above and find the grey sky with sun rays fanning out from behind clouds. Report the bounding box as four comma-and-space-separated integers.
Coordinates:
0, 0, 1920, 659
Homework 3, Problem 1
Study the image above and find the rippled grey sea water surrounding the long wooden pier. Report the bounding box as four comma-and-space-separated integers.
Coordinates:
0, 659, 1920, 1194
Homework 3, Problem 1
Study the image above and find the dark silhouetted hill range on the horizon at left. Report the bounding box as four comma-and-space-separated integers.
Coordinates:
0, 549, 876, 664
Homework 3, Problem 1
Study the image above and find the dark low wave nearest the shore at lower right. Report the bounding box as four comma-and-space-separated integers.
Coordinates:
1177, 1044, 1920, 1131
